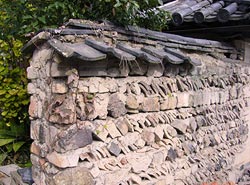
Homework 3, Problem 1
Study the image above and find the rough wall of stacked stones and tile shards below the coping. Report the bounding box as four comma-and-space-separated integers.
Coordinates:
27, 45, 250, 185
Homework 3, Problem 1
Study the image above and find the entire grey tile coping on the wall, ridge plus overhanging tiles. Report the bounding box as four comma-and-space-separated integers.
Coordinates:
23, 20, 237, 69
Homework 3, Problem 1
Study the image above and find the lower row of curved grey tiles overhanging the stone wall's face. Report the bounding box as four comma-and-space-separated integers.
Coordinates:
49, 39, 201, 66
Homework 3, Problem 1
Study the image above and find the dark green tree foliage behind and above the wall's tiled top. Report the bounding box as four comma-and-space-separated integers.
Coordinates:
0, 0, 169, 40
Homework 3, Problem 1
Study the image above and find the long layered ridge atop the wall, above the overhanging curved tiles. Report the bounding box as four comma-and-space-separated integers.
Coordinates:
23, 19, 236, 53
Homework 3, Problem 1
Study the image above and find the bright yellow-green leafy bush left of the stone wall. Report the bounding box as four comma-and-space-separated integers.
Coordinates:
0, 39, 29, 127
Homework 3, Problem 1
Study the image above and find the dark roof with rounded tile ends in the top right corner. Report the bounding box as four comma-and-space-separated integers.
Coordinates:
159, 0, 250, 26
